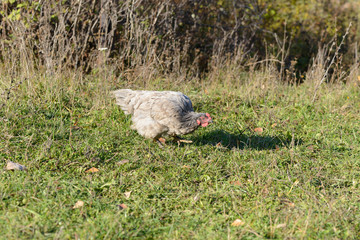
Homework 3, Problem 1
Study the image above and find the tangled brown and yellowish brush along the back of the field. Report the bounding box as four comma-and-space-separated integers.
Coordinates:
0, 0, 360, 78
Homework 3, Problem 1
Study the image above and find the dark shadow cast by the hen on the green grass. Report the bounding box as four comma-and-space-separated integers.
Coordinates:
192, 130, 303, 150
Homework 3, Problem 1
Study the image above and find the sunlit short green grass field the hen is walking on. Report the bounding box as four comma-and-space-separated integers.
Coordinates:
0, 76, 360, 239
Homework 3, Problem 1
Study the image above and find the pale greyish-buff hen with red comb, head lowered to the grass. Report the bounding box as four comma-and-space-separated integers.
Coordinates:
113, 89, 212, 140
